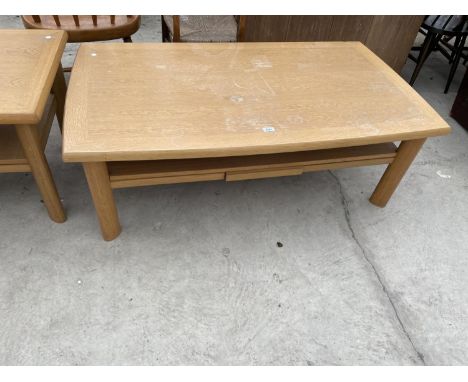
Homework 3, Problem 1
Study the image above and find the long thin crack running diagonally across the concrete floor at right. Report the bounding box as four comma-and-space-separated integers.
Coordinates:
329, 171, 426, 365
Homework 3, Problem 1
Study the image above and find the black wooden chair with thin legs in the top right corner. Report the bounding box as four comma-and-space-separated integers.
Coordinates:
410, 16, 468, 93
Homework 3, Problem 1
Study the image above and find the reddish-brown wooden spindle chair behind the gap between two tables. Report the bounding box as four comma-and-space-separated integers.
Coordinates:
21, 16, 140, 42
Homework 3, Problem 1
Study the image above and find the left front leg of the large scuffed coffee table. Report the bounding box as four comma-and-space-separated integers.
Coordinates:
83, 162, 121, 240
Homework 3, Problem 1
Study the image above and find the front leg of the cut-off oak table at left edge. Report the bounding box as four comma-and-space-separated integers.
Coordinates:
16, 125, 67, 223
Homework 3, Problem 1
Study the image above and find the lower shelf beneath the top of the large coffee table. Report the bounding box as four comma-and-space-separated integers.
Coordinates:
108, 143, 397, 188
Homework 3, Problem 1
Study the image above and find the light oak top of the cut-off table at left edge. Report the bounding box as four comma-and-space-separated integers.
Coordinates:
0, 29, 67, 128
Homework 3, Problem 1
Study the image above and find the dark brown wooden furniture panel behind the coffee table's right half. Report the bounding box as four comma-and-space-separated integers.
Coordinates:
243, 16, 423, 72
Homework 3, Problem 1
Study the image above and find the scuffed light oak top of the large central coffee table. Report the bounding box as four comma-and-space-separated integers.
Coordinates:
63, 42, 450, 162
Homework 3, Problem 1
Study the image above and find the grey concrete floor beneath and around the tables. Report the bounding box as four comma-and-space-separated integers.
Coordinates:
0, 17, 468, 365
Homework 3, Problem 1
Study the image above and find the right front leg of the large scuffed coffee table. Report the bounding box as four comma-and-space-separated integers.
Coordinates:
369, 138, 426, 207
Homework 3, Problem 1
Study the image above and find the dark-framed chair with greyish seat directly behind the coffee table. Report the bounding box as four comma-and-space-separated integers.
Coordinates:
161, 16, 245, 42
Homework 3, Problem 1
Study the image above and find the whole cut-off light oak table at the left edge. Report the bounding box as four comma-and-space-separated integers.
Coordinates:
0, 30, 67, 223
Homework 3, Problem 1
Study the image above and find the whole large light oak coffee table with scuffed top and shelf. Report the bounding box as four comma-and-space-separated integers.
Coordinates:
63, 42, 450, 240
